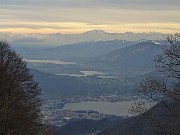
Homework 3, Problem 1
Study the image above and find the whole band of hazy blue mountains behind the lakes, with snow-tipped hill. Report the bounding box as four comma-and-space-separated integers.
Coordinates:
21, 40, 165, 76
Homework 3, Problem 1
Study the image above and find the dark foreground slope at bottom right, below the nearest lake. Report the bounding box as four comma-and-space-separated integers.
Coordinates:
97, 101, 180, 135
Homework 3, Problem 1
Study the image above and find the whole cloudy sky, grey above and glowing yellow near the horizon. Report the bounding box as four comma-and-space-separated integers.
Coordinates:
0, 0, 180, 34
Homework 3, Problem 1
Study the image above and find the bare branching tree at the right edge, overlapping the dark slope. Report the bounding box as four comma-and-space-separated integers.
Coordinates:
131, 33, 180, 135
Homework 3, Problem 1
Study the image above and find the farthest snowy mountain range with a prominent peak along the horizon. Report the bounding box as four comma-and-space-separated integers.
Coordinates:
0, 30, 167, 47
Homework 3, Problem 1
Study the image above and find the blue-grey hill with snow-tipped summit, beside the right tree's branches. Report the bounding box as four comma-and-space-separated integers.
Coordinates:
99, 41, 162, 74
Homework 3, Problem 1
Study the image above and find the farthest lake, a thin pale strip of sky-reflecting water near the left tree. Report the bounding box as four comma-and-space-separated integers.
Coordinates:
25, 59, 76, 65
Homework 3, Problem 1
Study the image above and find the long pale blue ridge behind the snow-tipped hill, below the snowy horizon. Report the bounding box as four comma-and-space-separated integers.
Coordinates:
17, 40, 134, 59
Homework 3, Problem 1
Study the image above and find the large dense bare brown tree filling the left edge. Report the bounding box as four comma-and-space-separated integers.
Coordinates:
0, 41, 53, 135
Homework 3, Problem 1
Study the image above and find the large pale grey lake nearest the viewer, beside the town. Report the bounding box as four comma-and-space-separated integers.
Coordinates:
63, 101, 135, 116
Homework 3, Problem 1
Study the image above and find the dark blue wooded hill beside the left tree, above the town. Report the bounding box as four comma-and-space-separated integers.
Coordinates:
31, 69, 90, 98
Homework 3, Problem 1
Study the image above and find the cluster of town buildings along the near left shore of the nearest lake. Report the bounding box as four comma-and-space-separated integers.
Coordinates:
43, 101, 106, 126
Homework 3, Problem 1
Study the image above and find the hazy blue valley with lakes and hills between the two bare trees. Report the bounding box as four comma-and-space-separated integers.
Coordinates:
14, 40, 166, 134
